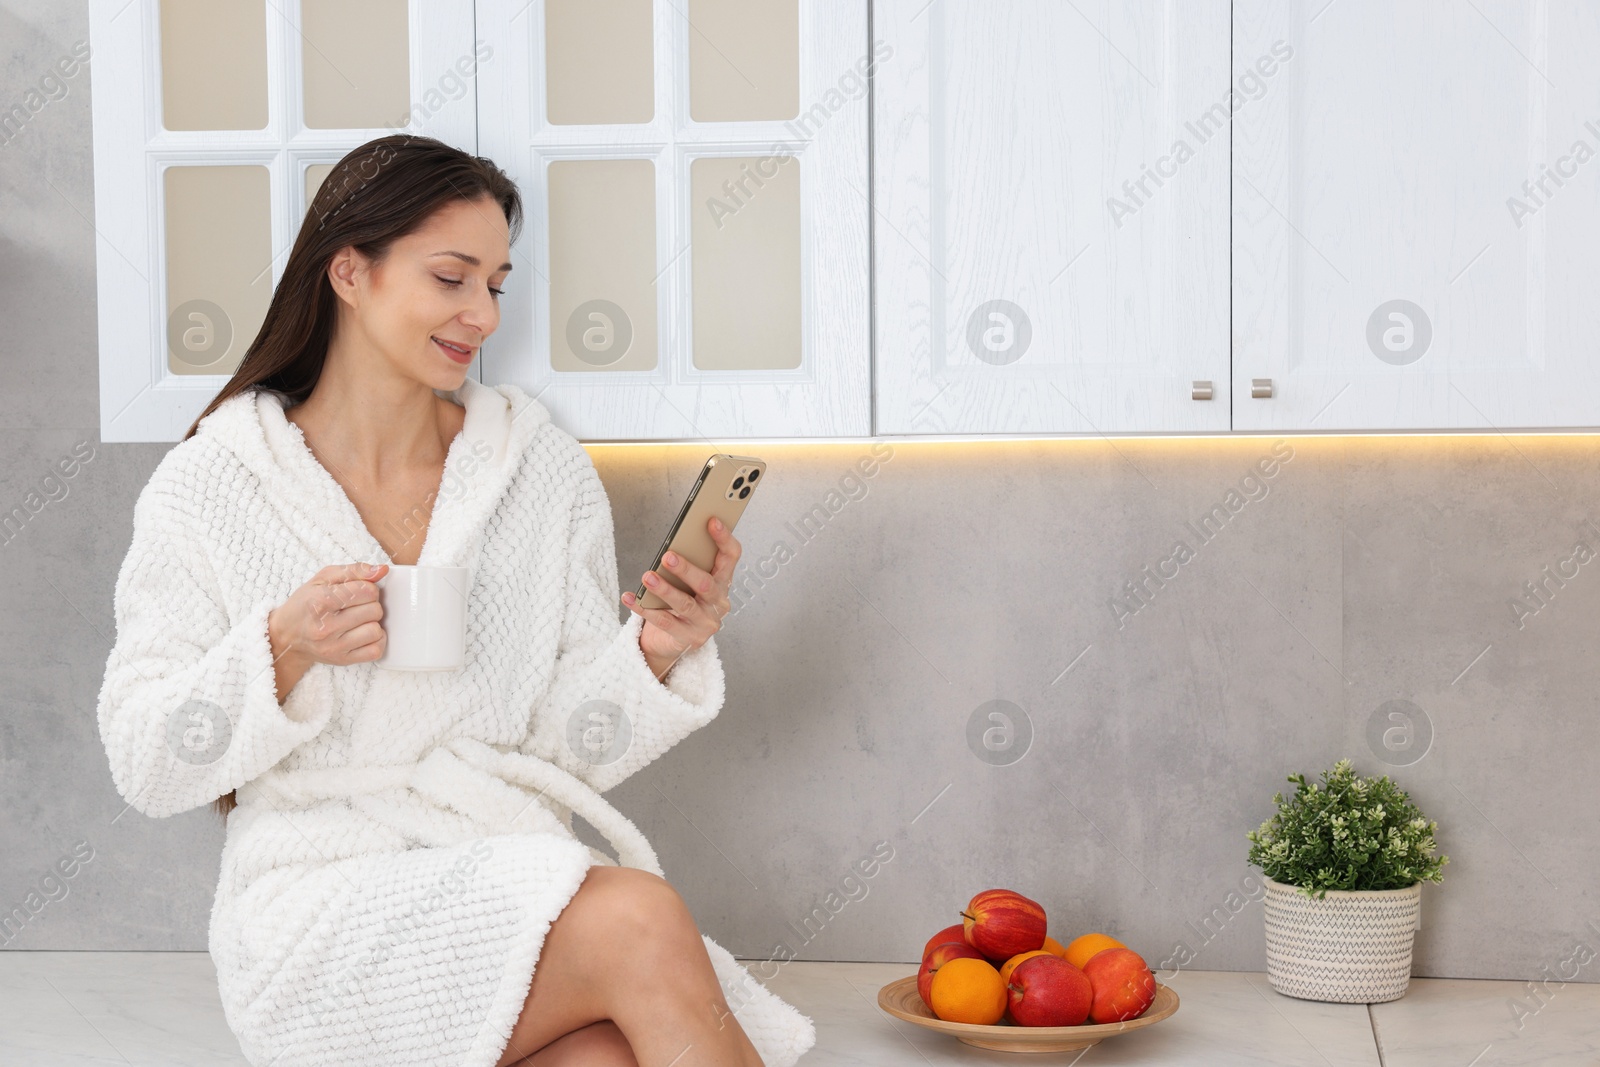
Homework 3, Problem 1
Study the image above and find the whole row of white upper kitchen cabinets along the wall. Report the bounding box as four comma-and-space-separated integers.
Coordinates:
90, 0, 1600, 442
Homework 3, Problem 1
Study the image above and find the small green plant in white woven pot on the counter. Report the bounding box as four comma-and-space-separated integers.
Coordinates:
1245, 760, 1450, 1003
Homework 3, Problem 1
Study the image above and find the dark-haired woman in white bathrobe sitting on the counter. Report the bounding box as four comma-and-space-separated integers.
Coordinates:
98, 136, 814, 1067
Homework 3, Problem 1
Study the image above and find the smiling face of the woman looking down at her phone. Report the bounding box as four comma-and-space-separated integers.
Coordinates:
328, 197, 510, 390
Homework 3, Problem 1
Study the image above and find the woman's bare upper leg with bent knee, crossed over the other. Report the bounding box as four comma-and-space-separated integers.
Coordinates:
499, 865, 762, 1067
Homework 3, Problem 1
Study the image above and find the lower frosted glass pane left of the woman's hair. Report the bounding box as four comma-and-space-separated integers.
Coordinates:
165, 166, 272, 374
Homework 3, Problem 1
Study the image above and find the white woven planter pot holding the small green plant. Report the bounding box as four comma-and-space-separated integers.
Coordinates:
1262, 878, 1422, 1005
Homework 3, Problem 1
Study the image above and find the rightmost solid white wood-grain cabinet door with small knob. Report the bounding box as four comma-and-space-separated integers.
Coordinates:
1234, 0, 1600, 430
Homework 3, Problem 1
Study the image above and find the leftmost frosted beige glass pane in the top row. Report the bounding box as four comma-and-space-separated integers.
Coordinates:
159, 0, 267, 130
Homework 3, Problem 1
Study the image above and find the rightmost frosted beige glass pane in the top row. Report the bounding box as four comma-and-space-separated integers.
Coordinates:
688, 0, 800, 122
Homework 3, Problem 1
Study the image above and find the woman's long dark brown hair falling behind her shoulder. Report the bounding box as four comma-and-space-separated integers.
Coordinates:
182, 134, 523, 821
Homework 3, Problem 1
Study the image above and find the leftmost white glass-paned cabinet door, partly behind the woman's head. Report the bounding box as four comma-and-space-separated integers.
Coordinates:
88, 0, 476, 442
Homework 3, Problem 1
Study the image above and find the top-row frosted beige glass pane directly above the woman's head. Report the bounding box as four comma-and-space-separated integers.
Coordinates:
301, 0, 409, 130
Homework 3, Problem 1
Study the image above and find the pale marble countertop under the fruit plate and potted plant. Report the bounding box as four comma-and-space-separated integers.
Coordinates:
0, 952, 1600, 1067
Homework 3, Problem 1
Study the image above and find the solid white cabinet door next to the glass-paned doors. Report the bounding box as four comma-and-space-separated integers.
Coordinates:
872, 0, 1232, 434
